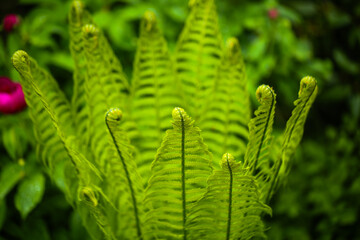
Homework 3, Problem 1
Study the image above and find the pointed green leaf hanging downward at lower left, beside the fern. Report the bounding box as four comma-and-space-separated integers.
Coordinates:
15, 173, 45, 219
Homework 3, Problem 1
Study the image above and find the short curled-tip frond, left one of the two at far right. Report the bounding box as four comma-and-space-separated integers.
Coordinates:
244, 85, 276, 173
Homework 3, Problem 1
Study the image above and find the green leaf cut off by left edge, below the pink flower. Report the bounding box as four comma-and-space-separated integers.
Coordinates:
0, 163, 24, 200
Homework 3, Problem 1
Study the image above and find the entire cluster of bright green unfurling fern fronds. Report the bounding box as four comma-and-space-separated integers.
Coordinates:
12, 0, 317, 240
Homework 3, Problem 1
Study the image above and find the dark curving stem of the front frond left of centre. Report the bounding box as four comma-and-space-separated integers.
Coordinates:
105, 118, 143, 240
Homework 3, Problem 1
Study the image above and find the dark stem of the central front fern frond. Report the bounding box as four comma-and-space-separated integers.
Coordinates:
177, 109, 186, 240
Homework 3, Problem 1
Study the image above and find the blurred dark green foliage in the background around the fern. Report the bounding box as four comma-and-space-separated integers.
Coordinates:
0, 0, 360, 239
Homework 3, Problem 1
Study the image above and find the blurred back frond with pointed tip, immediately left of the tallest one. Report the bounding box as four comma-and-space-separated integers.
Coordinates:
131, 11, 180, 184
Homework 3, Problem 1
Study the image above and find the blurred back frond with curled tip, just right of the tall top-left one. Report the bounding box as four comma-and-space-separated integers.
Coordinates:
83, 25, 134, 171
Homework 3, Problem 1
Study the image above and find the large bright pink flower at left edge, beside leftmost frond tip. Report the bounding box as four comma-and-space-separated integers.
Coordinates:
0, 77, 26, 114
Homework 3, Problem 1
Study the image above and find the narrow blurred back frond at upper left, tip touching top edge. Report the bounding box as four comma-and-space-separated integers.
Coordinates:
68, 1, 92, 144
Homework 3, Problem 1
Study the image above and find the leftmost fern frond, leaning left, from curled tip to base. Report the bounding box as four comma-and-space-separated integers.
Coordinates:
12, 51, 113, 239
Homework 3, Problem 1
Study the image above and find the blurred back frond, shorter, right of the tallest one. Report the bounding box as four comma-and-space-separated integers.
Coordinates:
200, 38, 250, 162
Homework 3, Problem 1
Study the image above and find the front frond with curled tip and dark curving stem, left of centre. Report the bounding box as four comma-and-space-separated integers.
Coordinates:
105, 109, 145, 239
